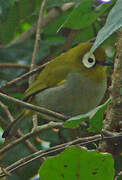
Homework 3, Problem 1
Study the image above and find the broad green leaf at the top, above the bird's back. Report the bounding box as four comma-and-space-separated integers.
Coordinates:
60, 0, 113, 29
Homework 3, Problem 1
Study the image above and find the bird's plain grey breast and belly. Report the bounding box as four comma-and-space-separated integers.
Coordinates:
35, 73, 106, 116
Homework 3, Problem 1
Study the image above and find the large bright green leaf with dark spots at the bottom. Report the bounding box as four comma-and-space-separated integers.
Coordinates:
39, 146, 115, 180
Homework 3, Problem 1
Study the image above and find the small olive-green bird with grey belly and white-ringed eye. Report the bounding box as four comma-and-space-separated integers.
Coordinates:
3, 42, 109, 137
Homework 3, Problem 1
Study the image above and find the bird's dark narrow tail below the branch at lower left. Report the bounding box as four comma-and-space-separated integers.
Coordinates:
2, 111, 25, 138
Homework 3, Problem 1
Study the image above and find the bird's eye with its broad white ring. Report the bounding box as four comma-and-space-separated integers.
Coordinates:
82, 52, 96, 68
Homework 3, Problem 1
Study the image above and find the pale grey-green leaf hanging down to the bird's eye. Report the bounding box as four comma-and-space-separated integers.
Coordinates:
91, 0, 122, 52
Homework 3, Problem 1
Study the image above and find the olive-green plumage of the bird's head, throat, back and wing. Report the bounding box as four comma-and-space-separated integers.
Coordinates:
23, 42, 106, 99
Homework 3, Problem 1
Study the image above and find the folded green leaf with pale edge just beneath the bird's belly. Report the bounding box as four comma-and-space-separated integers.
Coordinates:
64, 99, 110, 133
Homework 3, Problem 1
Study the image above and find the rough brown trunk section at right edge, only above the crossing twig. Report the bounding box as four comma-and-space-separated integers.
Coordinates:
106, 28, 122, 131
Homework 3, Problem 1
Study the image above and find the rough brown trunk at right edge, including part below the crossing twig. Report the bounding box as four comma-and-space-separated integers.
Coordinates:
99, 28, 122, 156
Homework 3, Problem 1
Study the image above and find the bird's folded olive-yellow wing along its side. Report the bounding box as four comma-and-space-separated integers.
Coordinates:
23, 63, 69, 100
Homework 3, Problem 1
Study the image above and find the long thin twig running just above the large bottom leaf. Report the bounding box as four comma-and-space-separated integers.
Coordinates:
0, 134, 122, 177
